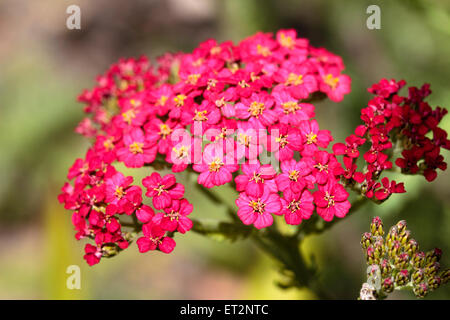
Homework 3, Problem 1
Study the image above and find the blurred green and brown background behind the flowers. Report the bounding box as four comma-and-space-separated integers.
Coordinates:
0, 0, 450, 299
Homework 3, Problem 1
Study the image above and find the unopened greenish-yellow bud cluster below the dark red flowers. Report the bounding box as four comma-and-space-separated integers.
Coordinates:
360, 217, 450, 299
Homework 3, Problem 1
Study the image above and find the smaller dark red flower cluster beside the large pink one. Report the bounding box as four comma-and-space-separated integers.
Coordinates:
333, 79, 450, 201
